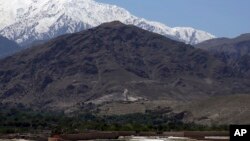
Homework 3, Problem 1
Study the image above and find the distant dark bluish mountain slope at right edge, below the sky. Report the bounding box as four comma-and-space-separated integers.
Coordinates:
196, 34, 250, 77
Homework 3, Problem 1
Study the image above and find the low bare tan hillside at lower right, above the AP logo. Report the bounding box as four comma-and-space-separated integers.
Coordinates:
181, 93, 250, 125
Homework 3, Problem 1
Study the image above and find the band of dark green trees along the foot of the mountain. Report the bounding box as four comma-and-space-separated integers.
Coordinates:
0, 109, 228, 133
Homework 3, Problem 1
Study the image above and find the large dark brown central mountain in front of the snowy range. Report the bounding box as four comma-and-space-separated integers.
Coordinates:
0, 22, 247, 110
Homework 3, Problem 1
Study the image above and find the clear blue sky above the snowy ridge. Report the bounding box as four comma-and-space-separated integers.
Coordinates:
96, 0, 250, 37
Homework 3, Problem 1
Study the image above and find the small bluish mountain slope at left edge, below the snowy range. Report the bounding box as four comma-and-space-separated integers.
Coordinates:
0, 36, 20, 58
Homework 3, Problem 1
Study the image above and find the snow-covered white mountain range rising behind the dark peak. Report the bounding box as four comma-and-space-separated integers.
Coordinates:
0, 0, 215, 45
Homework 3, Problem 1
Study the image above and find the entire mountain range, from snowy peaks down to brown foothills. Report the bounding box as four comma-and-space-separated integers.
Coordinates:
0, 0, 250, 124
